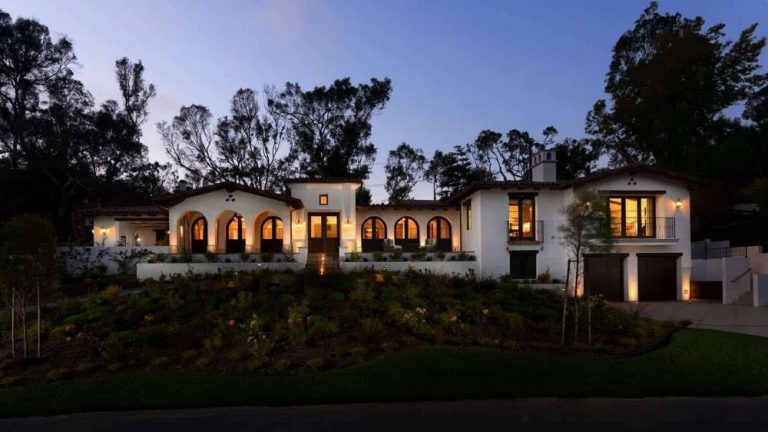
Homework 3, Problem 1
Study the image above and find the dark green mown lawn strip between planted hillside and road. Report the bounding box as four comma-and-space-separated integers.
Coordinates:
0, 330, 768, 417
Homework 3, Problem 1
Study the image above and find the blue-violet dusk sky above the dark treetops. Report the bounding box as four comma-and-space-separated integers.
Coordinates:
0, 0, 768, 201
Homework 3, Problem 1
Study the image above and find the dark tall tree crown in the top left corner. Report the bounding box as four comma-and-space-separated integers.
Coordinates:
0, 10, 75, 171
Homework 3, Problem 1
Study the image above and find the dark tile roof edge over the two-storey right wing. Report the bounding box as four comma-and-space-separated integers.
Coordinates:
446, 164, 704, 204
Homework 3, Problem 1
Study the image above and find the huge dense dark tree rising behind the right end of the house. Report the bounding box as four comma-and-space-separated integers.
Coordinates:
587, 2, 768, 175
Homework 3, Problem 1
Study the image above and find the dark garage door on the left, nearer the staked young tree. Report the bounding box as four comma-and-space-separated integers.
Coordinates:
584, 254, 627, 301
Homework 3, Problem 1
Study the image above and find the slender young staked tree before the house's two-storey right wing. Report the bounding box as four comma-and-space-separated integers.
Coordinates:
558, 190, 613, 343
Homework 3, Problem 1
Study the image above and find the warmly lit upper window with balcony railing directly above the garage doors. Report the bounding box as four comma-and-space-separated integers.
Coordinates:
608, 196, 656, 237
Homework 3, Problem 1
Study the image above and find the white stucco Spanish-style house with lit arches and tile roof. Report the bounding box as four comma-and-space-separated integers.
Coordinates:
84, 151, 691, 301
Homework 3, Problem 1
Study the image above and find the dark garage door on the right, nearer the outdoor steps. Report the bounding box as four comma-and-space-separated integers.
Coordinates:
637, 254, 680, 301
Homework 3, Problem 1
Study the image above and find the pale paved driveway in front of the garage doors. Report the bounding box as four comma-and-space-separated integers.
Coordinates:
622, 301, 768, 337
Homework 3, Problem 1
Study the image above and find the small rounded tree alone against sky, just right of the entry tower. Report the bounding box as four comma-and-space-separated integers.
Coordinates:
384, 143, 427, 203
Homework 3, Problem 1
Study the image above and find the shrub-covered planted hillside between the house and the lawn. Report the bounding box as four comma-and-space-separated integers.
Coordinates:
1, 272, 674, 386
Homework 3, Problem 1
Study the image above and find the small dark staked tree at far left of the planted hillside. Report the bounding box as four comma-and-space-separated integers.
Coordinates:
0, 216, 56, 357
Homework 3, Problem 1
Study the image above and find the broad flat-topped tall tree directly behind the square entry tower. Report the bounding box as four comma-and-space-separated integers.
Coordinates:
268, 78, 392, 179
